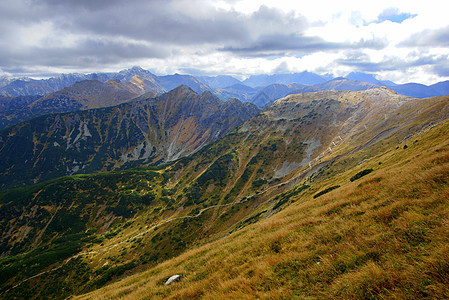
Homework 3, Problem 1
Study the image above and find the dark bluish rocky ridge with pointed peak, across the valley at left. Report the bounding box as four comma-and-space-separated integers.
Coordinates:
0, 86, 259, 188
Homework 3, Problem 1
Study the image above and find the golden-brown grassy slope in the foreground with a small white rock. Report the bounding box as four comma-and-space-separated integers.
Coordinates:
79, 117, 449, 299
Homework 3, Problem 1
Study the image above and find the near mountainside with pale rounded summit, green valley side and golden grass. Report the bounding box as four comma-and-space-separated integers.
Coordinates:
0, 88, 449, 298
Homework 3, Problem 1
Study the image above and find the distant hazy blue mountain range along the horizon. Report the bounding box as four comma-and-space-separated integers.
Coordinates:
0, 67, 449, 109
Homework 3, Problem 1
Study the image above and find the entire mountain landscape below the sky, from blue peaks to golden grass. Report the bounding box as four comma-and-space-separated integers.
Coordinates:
0, 61, 449, 299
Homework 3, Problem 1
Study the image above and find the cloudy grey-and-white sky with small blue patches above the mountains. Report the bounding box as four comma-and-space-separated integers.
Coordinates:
0, 0, 449, 84
